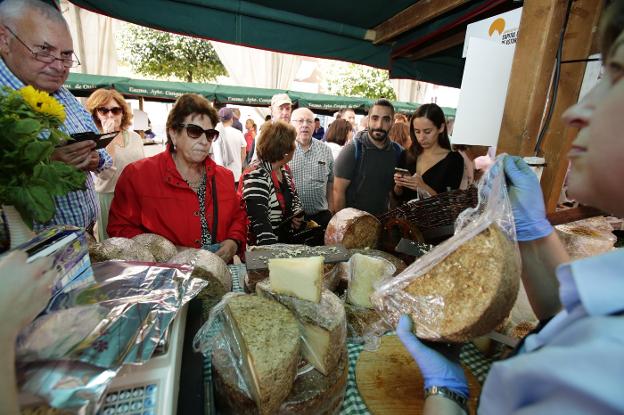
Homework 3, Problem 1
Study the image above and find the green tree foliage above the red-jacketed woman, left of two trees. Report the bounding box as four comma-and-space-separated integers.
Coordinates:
121, 24, 227, 82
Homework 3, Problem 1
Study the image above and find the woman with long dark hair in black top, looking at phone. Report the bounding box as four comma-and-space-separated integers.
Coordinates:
394, 104, 464, 202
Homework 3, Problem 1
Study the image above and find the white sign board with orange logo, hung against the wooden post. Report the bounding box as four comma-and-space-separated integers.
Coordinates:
451, 38, 515, 146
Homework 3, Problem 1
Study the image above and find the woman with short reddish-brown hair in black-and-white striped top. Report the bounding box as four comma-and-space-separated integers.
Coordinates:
239, 121, 303, 245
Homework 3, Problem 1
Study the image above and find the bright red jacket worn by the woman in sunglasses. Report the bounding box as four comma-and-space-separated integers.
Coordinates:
106, 149, 247, 255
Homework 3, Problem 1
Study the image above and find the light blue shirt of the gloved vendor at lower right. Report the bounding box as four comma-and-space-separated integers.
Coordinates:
479, 249, 624, 415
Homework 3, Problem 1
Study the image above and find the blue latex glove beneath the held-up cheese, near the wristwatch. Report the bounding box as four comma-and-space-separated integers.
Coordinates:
396, 315, 468, 398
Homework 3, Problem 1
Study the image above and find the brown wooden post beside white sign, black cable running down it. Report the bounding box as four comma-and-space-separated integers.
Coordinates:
497, 0, 603, 212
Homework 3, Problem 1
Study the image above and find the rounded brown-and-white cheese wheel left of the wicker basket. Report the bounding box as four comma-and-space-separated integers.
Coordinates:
325, 208, 381, 249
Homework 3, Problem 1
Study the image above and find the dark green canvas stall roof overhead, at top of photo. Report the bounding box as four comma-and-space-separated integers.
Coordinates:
70, 0, 519, 87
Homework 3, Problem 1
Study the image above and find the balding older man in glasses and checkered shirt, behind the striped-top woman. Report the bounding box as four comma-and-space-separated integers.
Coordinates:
289, 108, 334, 243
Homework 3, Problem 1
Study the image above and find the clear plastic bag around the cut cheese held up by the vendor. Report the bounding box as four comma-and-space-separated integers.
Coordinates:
370, 155, 520, 342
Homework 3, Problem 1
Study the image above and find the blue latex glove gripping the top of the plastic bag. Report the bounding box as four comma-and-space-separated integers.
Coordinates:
504, 156, 553, 241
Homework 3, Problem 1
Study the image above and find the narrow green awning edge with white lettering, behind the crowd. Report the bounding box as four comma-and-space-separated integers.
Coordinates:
65, 73, 455, 117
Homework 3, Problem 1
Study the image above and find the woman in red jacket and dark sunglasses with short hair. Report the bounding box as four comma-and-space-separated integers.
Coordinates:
107, 94, 247, 262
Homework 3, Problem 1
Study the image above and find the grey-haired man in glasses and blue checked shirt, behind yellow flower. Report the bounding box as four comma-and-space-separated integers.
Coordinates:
0, 0, 112, 232
